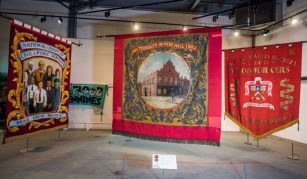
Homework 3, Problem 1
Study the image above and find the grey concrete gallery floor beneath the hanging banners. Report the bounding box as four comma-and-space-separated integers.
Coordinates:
0, 130, 307, 179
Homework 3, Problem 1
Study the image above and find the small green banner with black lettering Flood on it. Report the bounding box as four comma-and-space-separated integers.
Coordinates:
69, 84, 108, 110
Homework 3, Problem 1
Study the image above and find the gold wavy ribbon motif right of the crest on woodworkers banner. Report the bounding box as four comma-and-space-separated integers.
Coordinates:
280, 79, 295, 110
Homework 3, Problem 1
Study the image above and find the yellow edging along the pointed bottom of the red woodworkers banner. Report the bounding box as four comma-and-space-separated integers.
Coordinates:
225, 112, 299, 139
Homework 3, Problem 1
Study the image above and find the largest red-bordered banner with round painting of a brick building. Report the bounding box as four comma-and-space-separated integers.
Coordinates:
113, 28, 221, 145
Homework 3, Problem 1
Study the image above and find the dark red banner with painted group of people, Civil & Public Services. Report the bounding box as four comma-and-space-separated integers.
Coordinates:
3, 20, 71, 143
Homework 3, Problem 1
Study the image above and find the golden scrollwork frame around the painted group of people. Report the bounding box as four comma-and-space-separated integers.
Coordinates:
6, 30, 71, 132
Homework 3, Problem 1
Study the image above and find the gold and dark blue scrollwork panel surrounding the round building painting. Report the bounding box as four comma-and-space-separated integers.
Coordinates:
123, 34, 208, 126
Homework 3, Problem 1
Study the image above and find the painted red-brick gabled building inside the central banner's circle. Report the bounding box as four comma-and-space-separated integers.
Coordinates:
138, 60, 190, 96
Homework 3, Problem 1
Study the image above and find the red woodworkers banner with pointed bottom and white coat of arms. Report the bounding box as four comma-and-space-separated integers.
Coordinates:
225, 43, 302, 138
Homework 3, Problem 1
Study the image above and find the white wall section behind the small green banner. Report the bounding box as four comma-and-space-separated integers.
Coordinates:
69, 38, 114, 129
